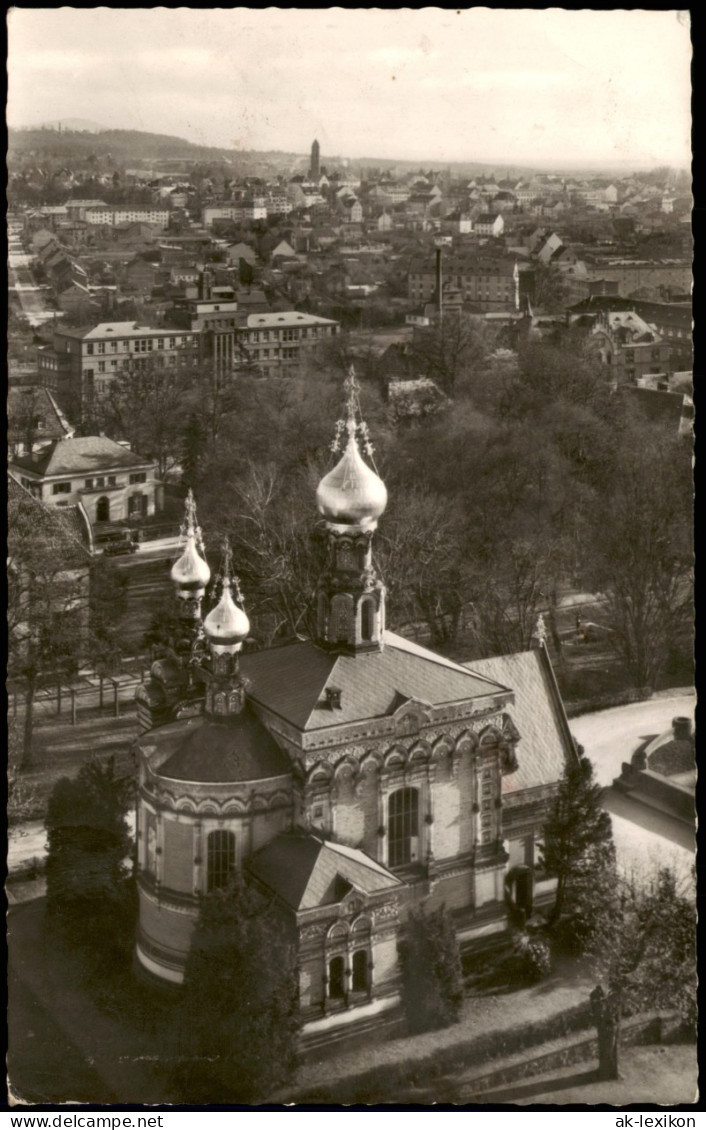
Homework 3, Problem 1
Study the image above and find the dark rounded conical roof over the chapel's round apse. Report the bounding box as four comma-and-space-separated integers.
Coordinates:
141, 706, 291, 783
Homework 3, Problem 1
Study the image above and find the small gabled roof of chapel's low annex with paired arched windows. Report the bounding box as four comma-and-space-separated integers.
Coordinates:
246, 832, 402, 911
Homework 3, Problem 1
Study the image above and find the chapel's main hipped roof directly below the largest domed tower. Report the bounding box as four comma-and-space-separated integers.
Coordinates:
242, 632, 508, 731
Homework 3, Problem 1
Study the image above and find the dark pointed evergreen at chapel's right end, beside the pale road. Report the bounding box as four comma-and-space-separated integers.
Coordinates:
542, 746, 617, 951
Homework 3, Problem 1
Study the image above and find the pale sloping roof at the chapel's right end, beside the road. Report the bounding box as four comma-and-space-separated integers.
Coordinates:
468, 647, 575, 792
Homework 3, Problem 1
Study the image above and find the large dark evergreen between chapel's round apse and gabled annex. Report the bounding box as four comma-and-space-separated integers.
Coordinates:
178, 876, 298, 1103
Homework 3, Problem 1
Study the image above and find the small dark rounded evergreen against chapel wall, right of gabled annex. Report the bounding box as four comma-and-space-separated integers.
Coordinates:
399, 906, 463, 1032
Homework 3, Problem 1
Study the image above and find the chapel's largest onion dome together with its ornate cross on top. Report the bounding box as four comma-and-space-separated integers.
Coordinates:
316, 368, 387, 527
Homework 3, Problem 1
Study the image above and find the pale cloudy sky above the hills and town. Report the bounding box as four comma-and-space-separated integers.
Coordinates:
8, 7, 691, 167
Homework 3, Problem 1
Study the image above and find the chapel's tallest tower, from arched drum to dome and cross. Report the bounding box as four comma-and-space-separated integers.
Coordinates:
316, 367, 387, 653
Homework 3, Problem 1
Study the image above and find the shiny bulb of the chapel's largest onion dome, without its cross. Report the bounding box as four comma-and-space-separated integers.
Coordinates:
316, 436, 387, 525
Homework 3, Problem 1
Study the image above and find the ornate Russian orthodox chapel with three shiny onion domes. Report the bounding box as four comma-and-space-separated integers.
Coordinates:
137, 372, 575, 1036
